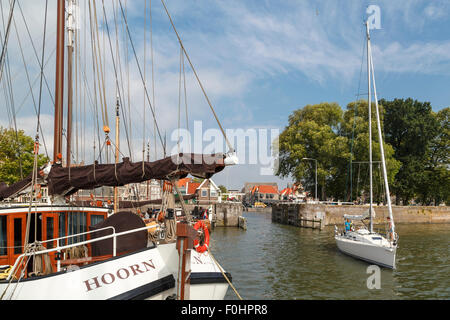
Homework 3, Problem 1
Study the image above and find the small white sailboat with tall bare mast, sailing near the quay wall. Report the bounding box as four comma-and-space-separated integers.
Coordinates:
335, 22, 398, 269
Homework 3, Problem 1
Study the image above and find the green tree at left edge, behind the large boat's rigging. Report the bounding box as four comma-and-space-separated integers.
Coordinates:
0, 127, 48, 184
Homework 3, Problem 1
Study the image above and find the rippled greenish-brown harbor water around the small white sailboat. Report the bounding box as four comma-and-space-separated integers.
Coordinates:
211, 212, 450, 300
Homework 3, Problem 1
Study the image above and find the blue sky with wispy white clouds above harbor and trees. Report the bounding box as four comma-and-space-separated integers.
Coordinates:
0, 0, 450, 189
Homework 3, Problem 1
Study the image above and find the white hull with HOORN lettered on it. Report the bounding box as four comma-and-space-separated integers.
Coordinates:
0, 243, 228, 300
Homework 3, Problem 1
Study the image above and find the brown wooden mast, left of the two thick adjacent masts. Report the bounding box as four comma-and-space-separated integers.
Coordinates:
53, 0, 66, 163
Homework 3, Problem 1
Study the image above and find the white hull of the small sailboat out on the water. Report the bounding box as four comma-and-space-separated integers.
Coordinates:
335, 235, 396, 269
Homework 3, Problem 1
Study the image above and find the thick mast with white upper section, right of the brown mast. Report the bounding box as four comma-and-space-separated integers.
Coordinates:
66, 0, 75, 167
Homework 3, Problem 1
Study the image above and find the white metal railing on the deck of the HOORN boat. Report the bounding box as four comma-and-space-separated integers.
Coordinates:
6, 225, 158, 281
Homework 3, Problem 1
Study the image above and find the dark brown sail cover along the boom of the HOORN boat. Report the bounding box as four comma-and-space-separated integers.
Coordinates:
47, 153, 225, 196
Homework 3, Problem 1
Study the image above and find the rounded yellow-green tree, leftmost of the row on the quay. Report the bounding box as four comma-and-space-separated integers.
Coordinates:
277, 103, 350, 199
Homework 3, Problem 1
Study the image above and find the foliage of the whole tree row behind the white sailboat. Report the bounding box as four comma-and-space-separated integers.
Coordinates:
277, 99, 450, 205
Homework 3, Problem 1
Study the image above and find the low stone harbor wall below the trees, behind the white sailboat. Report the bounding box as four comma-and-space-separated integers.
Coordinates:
272, 204, 450, 226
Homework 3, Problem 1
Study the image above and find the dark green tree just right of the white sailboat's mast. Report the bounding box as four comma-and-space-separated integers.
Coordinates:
380, 98, 439, 204
